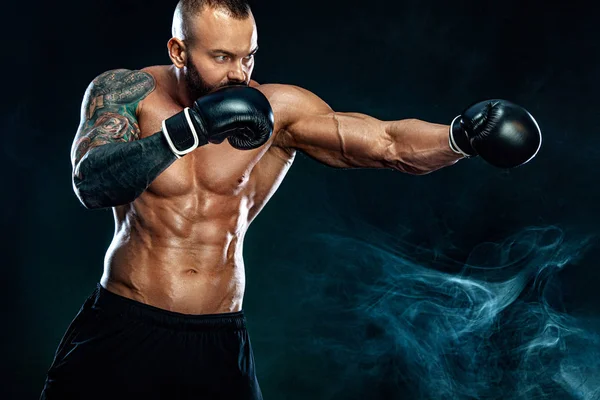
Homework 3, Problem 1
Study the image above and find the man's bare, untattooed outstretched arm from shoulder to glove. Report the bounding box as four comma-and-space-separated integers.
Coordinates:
272, 85, 462, 175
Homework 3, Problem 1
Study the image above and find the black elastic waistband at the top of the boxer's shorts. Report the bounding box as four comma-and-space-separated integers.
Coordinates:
88, 283, 246, 330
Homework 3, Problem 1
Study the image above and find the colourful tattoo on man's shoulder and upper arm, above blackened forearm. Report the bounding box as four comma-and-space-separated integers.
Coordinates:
71, 69, 156, 166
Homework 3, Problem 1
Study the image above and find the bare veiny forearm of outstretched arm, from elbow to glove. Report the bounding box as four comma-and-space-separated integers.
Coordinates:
383, 119, 463, 175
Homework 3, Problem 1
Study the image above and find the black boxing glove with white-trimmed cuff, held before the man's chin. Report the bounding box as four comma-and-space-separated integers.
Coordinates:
162, 85, 274, 158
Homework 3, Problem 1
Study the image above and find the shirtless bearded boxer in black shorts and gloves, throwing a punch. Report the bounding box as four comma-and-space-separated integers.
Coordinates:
42, 0, 541, 400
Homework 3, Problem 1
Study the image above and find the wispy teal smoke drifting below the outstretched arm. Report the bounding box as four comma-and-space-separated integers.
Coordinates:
290, 227, 600, 400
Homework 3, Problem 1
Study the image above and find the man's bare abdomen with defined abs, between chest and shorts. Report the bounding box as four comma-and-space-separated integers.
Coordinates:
101, 188, 248, 314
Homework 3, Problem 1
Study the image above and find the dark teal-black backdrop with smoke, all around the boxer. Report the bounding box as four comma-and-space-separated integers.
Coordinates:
0, 0, 600, 400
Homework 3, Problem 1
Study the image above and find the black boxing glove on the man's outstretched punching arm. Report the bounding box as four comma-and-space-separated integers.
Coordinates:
449, 100, 542, 168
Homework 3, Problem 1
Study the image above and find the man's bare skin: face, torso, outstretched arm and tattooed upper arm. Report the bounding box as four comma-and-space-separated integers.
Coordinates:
71, 4, 461, 314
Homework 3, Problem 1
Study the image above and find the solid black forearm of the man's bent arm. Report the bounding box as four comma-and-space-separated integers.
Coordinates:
73, 133, 177, 208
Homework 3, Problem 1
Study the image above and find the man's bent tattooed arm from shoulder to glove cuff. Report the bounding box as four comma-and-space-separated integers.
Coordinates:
71, 69, 177, 208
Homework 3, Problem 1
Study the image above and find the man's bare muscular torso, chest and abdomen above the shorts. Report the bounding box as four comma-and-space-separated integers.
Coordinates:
101, 66, 294, 314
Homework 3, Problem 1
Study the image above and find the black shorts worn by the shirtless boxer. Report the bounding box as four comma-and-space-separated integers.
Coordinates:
41, 284, 262, 400
